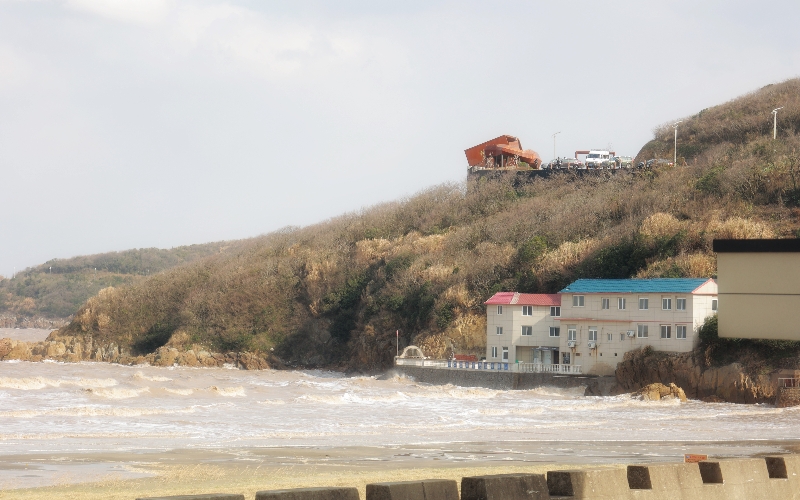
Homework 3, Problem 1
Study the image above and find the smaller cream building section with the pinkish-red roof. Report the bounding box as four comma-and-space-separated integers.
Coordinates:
485, 292, 561, 365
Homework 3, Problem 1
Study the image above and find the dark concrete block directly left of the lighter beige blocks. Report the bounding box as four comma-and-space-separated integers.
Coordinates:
461, 474, 550, 500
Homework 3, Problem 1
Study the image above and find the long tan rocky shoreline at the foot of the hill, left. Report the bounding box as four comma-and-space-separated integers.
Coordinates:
0, 335, 283, 370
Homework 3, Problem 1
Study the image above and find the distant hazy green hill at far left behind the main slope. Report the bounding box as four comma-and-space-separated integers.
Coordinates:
0, 242, 234, 320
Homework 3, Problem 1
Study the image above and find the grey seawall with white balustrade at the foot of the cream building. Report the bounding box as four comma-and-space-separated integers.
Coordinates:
394, 366, 616, 396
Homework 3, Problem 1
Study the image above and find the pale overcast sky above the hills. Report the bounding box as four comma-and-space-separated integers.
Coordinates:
0, 0, 800, 276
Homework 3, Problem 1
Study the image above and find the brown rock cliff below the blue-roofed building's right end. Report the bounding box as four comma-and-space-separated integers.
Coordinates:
616, 351, 800, 404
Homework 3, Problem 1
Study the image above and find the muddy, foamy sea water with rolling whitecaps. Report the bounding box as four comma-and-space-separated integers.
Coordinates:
0, 361, 800, 484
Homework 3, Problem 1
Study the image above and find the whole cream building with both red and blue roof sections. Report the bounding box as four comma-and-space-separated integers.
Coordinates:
486, 278, 717, 375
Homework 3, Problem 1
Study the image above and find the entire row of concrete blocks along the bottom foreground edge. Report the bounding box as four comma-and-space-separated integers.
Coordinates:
137, 455, 800, 500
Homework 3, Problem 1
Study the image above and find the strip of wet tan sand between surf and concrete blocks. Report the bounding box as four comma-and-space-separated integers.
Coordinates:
0, 441, 800, 499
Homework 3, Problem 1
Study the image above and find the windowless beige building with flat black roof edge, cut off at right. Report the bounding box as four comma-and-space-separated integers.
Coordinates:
714, 239, 800, 340
